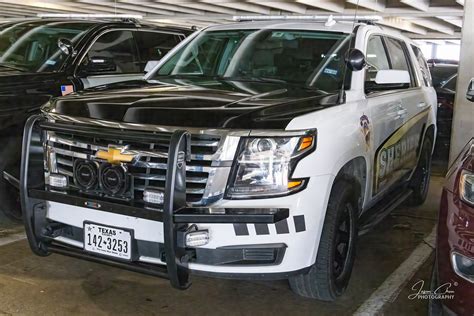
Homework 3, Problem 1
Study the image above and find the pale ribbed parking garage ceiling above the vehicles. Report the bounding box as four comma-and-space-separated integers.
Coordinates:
0, 0, 464, 39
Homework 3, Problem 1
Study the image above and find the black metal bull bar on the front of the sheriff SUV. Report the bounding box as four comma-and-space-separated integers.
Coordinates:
20, 115, 289, 289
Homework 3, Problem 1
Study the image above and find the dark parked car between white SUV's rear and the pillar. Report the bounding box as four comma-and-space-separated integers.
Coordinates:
430, 64, 458, 170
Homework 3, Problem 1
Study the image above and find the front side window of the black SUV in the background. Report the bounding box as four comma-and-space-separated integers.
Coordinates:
81, 31, 141, 74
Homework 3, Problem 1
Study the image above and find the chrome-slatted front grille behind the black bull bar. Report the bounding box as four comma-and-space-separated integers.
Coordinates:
45, 129, 220, 203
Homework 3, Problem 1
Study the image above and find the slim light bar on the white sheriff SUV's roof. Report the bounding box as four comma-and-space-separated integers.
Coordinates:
233, 15, 382, 22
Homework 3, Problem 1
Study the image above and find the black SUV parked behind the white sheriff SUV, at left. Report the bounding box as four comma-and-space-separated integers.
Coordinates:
0, 19, 190, 216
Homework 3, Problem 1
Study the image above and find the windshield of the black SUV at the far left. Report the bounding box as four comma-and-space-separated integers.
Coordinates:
0, 21, 91, 72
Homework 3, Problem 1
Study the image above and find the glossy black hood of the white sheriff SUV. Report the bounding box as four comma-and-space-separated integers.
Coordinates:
44, 79, 337, 129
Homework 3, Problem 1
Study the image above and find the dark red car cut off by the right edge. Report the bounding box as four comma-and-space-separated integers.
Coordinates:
430, 81, 474, 315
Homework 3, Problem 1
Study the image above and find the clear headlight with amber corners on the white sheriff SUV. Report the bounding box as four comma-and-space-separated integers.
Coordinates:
226, 133, 316, 199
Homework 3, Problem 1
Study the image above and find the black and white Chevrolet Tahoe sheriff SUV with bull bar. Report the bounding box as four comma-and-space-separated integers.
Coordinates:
20, 21, 436, 300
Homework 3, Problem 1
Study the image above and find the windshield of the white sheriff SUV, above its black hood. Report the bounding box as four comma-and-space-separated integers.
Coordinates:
154, 30, 349, 91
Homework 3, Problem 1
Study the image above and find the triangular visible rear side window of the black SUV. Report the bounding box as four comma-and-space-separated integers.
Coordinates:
134, 31, 181, 72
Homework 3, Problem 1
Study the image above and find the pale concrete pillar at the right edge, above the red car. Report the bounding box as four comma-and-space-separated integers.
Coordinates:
449, 0, 474, 164
